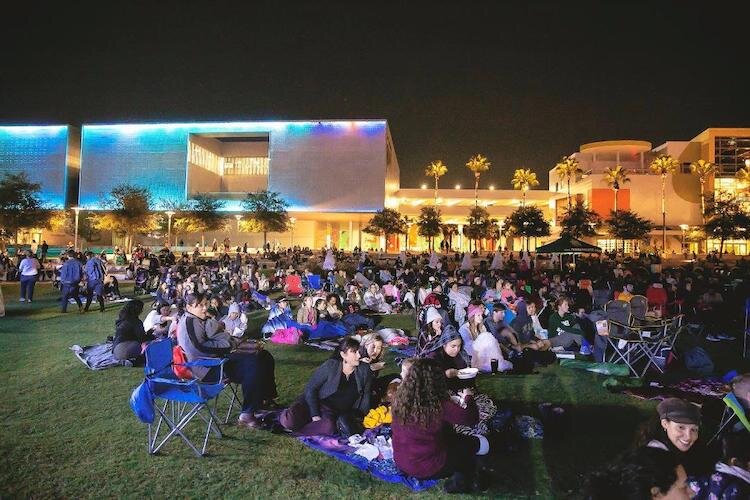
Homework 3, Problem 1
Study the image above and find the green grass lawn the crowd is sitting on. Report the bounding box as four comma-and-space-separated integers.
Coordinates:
0, 284, 744, 498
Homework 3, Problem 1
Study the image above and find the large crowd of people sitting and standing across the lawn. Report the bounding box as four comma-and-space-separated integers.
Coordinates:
5, 243, 750, 498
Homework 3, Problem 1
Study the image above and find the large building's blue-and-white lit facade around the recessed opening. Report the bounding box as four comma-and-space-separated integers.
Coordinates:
80, 120, 387, 212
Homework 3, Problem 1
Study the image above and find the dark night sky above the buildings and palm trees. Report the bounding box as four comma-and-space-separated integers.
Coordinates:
0, 0, 750, 187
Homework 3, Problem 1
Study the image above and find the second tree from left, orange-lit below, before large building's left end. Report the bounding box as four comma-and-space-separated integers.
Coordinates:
93, 184, 159, 252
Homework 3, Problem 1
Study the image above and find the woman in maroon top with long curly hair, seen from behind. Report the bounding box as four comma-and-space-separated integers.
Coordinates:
392, 359, 489, 493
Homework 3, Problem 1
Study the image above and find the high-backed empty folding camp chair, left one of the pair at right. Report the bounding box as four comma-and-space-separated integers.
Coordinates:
604, 300, 664, 377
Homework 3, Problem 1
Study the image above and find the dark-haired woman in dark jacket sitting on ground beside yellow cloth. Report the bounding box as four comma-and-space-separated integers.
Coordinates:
279, 337, 373, 436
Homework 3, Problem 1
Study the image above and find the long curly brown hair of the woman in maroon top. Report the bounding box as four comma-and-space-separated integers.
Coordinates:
393, 358, 448, 427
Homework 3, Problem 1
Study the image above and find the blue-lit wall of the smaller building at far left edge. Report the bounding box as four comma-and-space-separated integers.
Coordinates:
0, 125, 75, 208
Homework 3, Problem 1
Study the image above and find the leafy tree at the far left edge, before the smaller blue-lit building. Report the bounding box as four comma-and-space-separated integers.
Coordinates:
0, 172, 52, 243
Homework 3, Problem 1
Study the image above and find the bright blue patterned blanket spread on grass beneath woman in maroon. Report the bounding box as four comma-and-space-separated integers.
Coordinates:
298, 436, 438, 491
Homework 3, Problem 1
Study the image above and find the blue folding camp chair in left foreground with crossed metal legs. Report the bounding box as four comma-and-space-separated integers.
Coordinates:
145, 339, 227, 457
